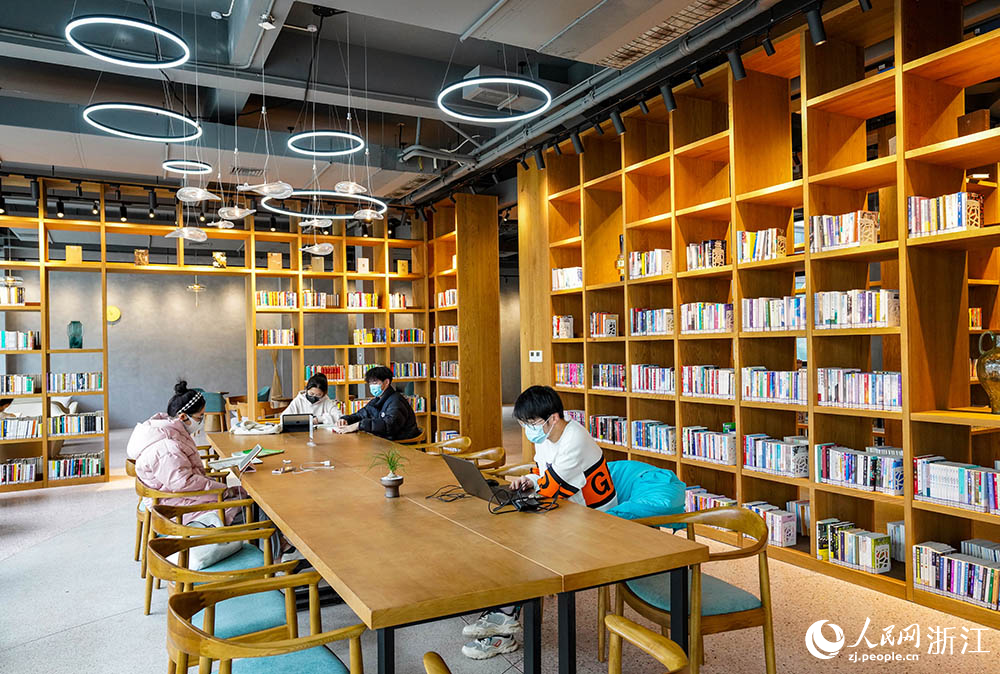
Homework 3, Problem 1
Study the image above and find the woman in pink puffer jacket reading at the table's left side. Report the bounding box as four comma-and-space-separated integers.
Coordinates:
126, 381, 246, 524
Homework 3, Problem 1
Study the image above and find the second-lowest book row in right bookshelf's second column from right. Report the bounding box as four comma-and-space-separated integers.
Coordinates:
816, 442, 903, 495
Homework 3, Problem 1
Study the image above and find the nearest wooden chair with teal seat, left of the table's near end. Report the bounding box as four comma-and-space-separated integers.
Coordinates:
167, 572, 365, 674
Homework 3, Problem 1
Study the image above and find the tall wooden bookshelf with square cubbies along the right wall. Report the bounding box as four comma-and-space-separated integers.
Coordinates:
518, 0, 1000, 627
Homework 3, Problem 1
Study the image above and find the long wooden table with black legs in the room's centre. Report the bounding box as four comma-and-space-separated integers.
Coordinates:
208, 430, 708, 674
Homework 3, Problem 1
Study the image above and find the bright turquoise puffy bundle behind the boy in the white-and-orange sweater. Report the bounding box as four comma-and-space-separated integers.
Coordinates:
607, 461, 685, 528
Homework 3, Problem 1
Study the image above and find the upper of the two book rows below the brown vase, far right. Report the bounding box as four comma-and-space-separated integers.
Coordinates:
913, 455, 1000, 513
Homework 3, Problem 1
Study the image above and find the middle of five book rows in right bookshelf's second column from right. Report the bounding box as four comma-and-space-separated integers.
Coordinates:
816, 367, 903, 412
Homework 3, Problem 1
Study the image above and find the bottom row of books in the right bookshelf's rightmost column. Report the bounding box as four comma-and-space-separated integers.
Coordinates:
913, 538, 1000, 610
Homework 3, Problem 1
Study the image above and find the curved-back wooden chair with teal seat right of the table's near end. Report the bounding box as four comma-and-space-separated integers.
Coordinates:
598, 507, 775, 674
